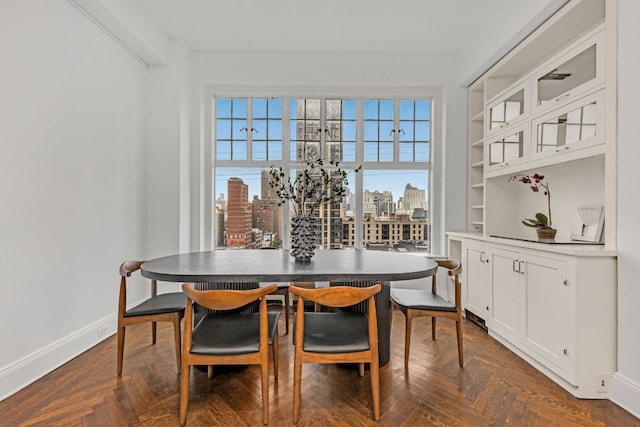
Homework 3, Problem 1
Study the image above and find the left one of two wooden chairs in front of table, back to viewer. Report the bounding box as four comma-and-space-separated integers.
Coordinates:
180, 284, 280, 425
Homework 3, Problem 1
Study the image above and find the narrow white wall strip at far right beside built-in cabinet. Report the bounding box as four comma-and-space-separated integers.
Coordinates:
611, 0, 640, 417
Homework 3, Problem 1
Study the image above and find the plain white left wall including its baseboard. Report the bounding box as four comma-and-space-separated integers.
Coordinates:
0, 0, 147, 399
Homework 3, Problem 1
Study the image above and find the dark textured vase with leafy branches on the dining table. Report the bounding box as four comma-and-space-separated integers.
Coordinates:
269, 157, 362, 261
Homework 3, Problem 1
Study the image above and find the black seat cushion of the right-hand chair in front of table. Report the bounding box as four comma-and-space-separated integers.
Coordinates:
294, 312, 370, 353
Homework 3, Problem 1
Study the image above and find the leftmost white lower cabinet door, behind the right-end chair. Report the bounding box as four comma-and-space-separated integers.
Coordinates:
462, 240, 489, 321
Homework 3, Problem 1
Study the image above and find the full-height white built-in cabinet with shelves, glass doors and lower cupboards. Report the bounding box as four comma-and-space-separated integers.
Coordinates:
448, 0, 617, 398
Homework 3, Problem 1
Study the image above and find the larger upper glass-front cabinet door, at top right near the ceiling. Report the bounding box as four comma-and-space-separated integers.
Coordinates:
533, 32, 604, 113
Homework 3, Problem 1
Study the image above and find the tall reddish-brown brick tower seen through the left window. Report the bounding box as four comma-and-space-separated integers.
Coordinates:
227, 177, 254, 248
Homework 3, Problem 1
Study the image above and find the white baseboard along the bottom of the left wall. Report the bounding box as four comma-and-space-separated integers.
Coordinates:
0, 313, 117, 400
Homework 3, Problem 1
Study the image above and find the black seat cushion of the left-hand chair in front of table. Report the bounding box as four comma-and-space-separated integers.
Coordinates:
191, 312, 280, 356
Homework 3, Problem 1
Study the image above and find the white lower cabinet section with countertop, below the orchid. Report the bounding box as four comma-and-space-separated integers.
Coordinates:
448, 232, 616, 398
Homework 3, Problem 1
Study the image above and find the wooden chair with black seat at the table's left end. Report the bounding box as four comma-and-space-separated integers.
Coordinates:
117, 261, 187, 376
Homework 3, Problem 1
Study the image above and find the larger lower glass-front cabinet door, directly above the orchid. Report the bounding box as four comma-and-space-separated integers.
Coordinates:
532, 90, 604, 158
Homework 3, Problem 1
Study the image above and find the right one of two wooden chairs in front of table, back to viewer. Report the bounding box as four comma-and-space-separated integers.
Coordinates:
289, 284, 381, 424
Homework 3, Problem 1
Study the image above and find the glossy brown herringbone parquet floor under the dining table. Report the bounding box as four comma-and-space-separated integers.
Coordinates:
0, 311, 640, 427
